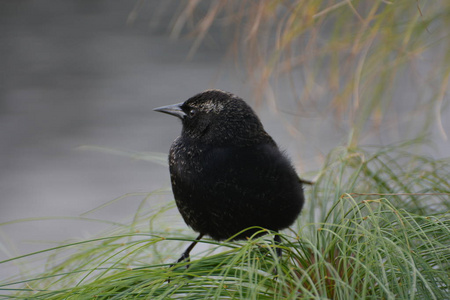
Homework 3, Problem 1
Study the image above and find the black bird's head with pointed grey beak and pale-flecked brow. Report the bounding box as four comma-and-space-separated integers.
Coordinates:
154, 90, 268, 146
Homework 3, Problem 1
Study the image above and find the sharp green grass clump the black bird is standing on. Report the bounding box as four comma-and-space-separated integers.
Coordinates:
0, 144, 450, 299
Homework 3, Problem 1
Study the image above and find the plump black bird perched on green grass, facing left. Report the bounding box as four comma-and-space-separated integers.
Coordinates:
155, 90, 304, 262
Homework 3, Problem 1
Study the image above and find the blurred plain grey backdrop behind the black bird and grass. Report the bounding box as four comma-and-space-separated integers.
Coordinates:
0, 0, 450, 275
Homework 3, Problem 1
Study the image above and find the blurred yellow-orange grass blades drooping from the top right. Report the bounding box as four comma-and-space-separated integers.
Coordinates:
148, 0, 450, 146
